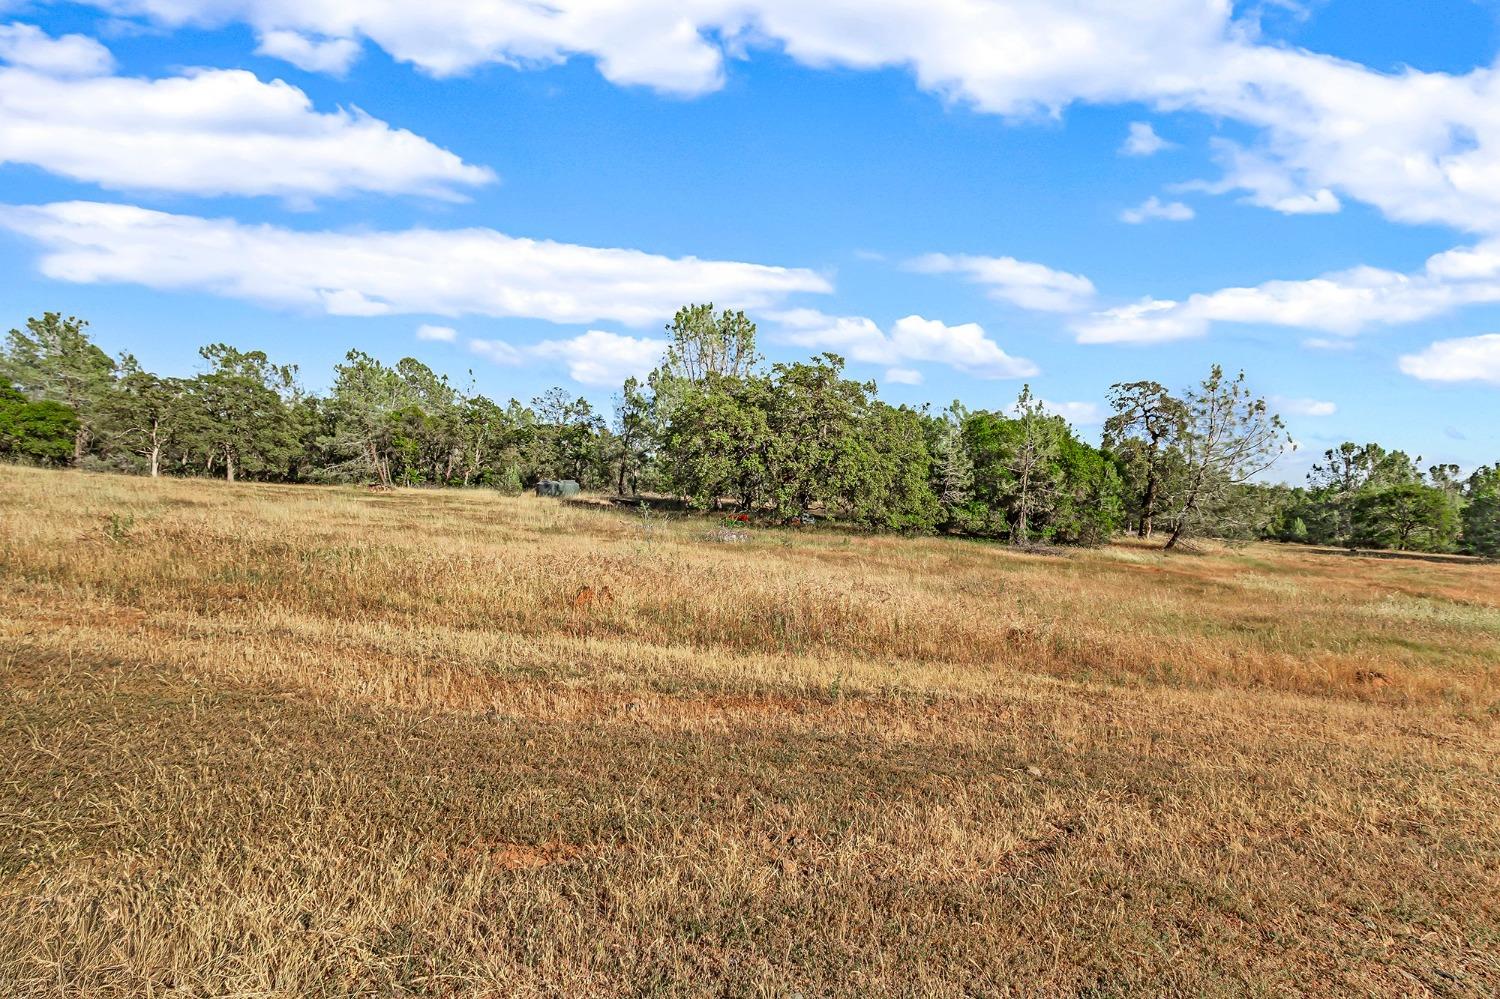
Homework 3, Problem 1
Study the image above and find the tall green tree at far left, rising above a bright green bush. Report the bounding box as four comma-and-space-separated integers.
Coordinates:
0, 312, 114, 465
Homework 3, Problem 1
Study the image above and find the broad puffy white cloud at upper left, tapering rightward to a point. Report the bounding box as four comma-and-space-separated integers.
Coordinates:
0, 54, 495, 198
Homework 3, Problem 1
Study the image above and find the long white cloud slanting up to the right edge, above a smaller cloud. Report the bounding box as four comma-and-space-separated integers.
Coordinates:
1074, 240, 1500, 348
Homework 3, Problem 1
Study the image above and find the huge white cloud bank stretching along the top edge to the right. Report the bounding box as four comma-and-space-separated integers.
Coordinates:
79, 0, 1500, 233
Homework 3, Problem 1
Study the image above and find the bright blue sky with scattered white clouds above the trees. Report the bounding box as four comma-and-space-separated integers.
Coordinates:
0, 0, 1500, 480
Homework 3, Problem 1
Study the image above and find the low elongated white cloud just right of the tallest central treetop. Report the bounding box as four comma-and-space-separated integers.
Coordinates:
767, 309, 1038, 378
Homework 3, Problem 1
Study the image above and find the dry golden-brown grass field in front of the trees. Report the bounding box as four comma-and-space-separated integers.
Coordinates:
0, 468, 1500, 998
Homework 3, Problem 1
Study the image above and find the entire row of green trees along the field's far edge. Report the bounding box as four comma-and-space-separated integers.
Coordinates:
0, 305, 1500, 555
